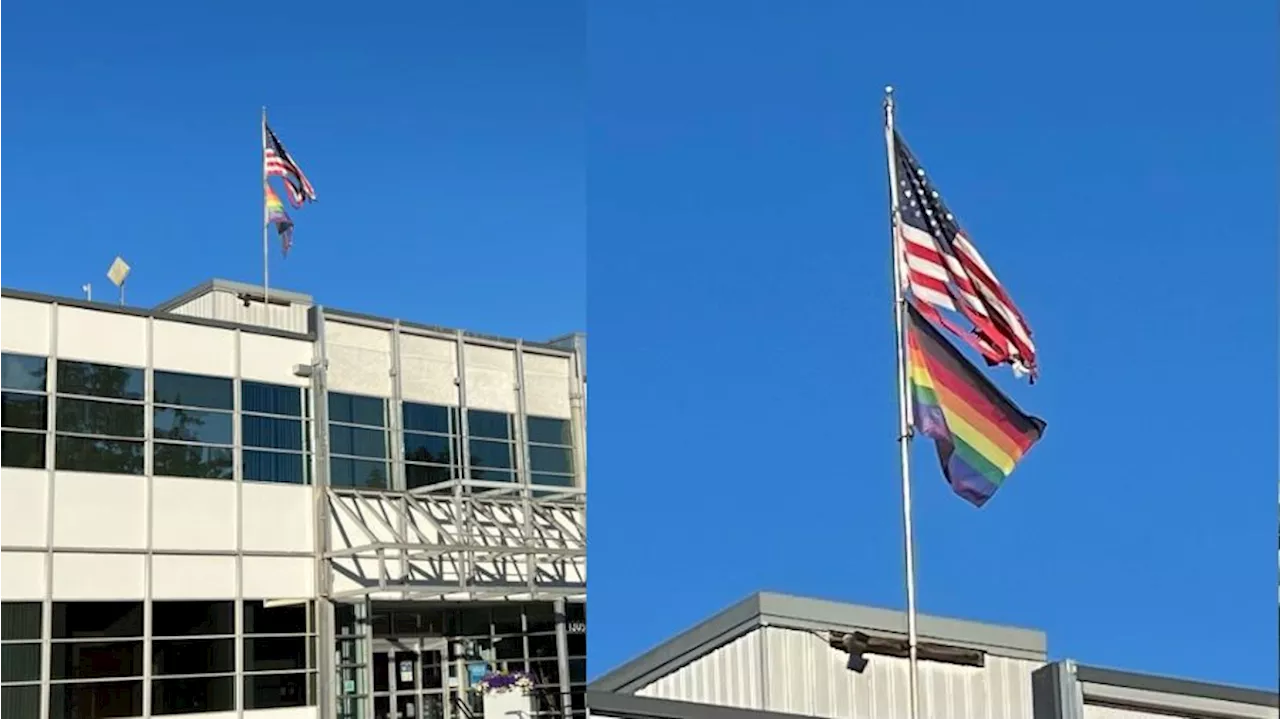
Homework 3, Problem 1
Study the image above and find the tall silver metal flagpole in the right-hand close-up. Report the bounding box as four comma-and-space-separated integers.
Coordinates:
884, 87, 920, 719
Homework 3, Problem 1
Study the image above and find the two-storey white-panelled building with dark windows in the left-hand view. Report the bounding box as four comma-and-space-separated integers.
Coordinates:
0, 280, 586, 719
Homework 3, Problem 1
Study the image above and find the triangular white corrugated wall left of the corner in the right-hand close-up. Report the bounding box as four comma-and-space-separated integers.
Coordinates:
636, 631, 764, 709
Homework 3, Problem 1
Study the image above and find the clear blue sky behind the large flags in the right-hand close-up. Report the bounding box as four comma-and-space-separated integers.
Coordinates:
586, 0, 1277, 687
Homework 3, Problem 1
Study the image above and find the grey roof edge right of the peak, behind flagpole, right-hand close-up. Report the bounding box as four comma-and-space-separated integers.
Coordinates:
760, 592, 1048, 661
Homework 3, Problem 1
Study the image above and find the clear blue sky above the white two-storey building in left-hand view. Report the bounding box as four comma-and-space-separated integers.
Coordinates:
0, 0, 586, 339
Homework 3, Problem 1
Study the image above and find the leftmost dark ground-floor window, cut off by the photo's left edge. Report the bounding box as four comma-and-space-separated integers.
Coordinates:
0, 601, 41, 719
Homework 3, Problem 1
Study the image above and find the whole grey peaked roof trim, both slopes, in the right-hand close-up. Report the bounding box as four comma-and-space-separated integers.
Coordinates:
590, 592, 1047, 693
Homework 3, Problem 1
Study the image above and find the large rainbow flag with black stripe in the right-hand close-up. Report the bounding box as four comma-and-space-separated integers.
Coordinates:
906, 300, 1046, 507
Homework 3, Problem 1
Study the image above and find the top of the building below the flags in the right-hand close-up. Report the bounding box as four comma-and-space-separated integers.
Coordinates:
588, 592, 1280, 719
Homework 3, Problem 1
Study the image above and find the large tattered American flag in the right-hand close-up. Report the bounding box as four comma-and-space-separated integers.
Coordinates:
893, 133, 1037, 381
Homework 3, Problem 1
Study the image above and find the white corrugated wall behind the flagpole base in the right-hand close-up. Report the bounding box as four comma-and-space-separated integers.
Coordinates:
763, 627, 1043, 719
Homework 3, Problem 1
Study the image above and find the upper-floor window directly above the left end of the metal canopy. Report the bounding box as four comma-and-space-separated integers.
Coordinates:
329, 393, 390, 489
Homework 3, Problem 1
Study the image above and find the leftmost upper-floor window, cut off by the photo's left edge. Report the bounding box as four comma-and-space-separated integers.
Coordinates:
0, 354, 49, 470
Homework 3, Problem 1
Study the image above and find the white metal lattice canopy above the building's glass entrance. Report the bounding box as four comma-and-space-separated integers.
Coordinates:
324, 484, 586, 601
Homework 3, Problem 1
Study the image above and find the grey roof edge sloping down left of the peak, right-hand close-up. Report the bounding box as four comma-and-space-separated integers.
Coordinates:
588, 592, 760, 693
